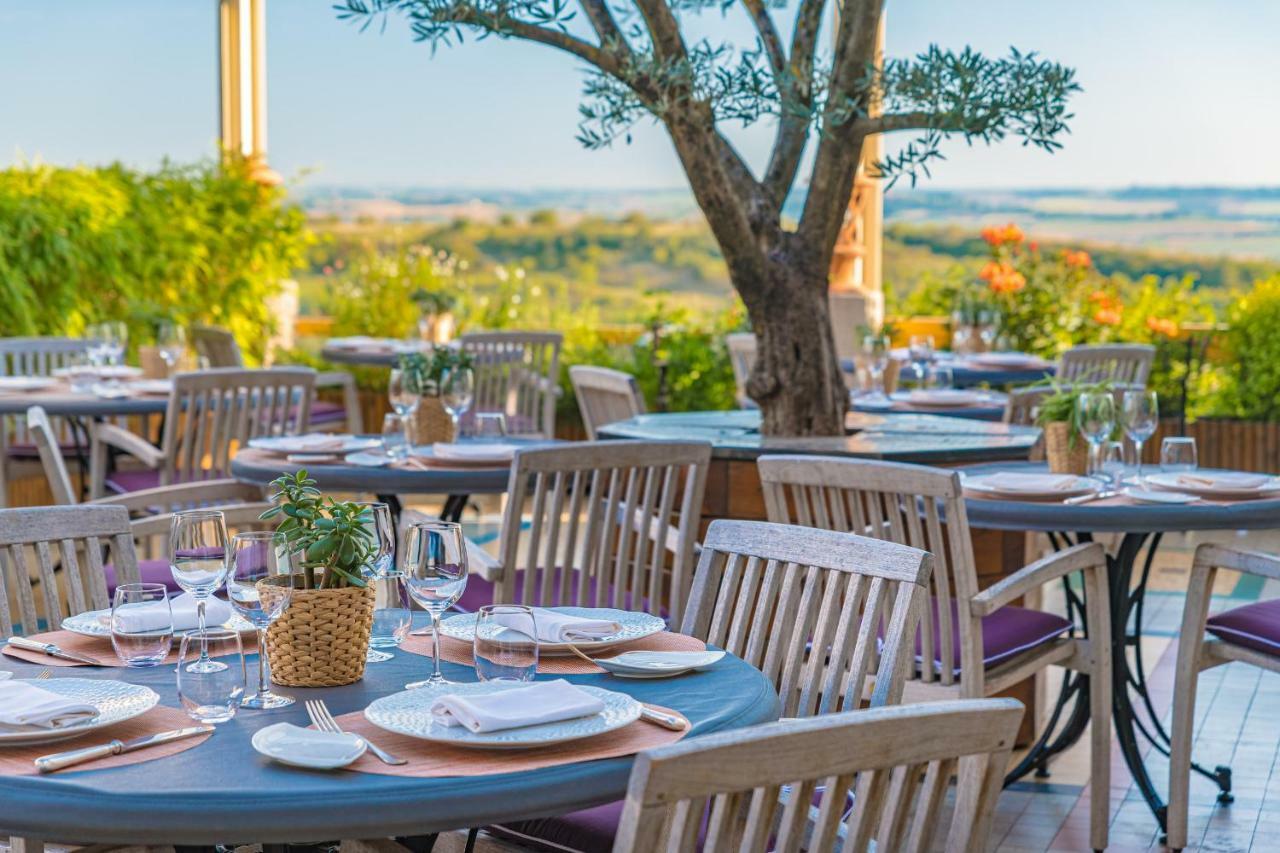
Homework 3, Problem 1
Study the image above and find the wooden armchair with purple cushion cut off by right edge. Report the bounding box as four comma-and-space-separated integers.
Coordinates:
1167, 544, 1280, 850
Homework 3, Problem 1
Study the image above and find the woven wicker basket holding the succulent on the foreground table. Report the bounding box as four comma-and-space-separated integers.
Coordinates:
260, 579, 375, 686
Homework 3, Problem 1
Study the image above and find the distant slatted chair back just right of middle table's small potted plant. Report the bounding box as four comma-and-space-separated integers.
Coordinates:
460, 332, 564, 438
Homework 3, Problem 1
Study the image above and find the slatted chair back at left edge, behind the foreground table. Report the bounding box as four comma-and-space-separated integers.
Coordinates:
0, 506, 138, 637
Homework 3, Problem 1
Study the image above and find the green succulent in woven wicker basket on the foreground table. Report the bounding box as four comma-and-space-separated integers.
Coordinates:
259, 470, 378, 686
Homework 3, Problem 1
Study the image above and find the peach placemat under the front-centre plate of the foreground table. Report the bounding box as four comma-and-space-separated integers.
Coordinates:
338, 704, 689, 779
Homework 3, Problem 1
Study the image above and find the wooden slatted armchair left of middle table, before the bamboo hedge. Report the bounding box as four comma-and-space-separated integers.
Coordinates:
90, 368, 315, 498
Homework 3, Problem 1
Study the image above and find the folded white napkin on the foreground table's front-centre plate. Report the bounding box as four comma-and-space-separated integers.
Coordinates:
431, 679, 604, 734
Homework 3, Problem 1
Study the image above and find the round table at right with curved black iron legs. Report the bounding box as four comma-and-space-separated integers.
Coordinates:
963, 462, 1280, 830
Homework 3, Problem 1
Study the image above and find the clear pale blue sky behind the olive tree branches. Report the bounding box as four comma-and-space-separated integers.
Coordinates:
0, 0, 1280, 188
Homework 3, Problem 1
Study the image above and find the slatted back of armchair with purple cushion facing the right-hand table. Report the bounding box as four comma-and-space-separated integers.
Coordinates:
756, 456, 982, 684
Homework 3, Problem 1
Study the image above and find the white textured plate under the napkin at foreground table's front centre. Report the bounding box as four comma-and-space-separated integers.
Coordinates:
365, 681, 640, 749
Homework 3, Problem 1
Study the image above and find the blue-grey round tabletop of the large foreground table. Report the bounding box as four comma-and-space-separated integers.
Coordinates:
0, 615, 780, 845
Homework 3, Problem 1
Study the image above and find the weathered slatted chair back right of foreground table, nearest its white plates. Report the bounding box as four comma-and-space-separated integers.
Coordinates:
682, 520, 933, 717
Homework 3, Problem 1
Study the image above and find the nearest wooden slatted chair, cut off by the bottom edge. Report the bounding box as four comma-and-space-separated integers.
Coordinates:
613, 699, 1023, 853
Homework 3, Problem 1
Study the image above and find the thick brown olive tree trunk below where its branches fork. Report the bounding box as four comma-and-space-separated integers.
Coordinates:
739, 258, 849, 435
